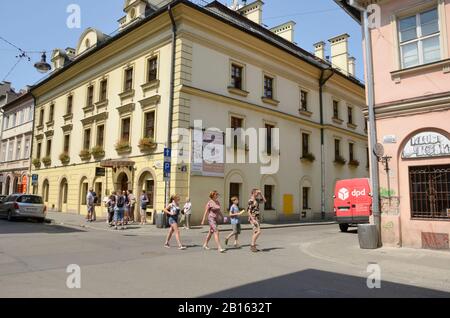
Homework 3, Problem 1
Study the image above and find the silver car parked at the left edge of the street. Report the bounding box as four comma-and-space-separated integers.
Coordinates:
0, 194, 47, 222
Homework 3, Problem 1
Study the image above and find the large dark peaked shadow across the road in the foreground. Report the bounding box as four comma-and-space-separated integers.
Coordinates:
201, 269, 450, 298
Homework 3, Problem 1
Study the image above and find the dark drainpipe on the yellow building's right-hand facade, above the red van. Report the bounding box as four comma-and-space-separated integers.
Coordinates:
319, 67, 334, 220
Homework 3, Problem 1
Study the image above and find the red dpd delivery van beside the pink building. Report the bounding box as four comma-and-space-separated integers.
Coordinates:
333, 178, 372, 232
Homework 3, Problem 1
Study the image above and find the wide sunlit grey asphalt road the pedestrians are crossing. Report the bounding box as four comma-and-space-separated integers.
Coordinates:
0, 220, 450, 298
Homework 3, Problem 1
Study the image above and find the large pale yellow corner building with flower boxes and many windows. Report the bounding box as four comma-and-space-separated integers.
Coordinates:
32, 0, 368, 222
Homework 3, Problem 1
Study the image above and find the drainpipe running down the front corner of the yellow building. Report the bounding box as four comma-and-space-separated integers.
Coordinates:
164, 4, 177, 206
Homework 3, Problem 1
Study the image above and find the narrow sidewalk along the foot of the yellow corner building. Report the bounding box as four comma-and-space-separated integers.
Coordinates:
47, 212, 335, 234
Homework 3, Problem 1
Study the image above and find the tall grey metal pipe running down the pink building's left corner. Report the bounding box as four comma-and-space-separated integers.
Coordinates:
363, 10, 381, 240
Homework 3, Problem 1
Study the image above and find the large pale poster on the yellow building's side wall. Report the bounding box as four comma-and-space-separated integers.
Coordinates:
191, 130, 225, 178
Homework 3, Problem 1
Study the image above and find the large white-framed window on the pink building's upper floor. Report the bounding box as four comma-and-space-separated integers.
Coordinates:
399, 8, 441, 68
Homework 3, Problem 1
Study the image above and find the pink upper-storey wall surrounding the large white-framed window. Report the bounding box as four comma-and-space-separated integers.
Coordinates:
372, 0, 450, 105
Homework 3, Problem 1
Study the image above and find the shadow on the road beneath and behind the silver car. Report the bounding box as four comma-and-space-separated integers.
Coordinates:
0, 219, 85, 234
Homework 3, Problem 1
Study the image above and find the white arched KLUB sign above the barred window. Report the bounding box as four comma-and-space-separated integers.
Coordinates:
402, 131, 450, 159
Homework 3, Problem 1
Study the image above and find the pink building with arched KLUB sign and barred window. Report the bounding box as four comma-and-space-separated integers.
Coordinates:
335, 0, 450, 249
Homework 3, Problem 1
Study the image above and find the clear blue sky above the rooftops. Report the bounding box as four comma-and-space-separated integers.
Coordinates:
0, 0, 363, 89
